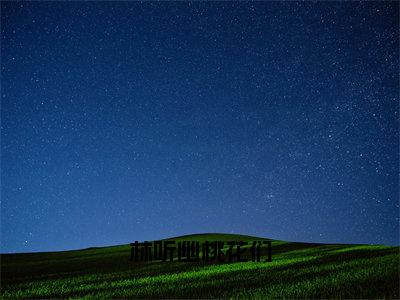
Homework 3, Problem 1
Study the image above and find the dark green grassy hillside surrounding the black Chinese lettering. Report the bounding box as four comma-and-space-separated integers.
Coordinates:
1, 234, 400, 299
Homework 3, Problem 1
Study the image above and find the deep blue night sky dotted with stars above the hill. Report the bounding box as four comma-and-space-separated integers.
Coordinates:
1, 1, 399, 252
